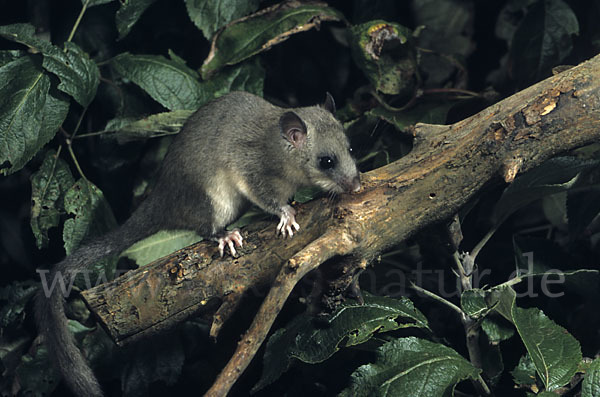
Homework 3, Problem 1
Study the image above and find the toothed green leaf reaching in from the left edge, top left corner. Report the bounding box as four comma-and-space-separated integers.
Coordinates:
0, 24, 100, 107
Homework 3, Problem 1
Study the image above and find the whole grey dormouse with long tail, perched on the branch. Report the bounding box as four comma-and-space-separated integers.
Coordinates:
35, 92, 360, 397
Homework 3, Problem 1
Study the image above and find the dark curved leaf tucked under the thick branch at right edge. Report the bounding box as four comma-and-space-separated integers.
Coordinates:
492, 157, 598, 225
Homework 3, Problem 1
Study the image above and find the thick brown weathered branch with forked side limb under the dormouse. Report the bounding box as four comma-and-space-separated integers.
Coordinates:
83, 56, 600, 396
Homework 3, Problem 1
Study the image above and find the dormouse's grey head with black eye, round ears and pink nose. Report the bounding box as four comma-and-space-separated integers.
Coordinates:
279, 93, 360, 193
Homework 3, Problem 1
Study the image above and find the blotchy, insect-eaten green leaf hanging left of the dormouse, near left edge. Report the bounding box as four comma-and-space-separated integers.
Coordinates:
30, 151, 75, 249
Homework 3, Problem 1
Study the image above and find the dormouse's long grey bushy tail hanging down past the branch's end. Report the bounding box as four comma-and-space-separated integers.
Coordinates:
35, 214, 153, 397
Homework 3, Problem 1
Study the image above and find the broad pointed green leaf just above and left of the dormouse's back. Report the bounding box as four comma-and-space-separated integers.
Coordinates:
111, 53, 212, 110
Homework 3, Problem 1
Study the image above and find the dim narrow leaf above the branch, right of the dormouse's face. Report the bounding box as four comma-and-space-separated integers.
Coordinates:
365, 101, 458, 130
